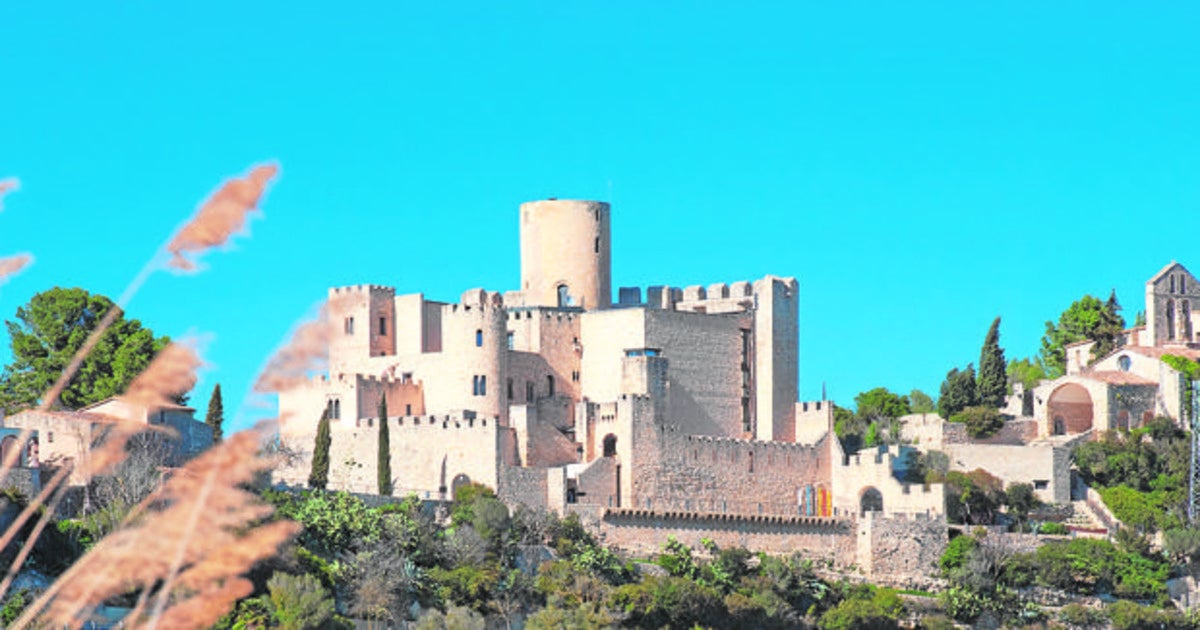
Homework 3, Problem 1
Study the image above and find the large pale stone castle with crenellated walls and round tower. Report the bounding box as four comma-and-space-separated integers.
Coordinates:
277, 199, 944, 578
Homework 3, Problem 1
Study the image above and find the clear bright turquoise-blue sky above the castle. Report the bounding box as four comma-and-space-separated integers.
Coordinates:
0, 1, 1200, 426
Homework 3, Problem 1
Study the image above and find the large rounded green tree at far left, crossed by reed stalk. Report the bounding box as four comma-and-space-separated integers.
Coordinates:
0, 287, 175, 410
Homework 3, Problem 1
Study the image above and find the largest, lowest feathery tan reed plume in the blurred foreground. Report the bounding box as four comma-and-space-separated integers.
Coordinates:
13, 427, 299, 628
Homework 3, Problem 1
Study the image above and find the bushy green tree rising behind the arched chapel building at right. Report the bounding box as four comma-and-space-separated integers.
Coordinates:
1040, 292, 1124, 378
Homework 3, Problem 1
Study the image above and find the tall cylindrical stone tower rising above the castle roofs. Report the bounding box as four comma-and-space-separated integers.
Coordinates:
521, 199, 612, 310
